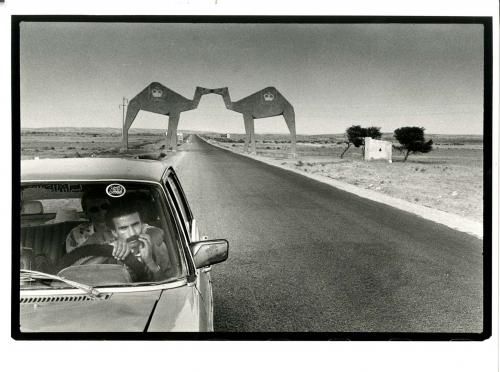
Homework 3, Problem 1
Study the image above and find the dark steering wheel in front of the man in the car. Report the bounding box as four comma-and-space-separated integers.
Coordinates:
56, 244, 146, 278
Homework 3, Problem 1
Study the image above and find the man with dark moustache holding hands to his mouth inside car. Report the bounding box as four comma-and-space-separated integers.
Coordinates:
102, 197, 171, 281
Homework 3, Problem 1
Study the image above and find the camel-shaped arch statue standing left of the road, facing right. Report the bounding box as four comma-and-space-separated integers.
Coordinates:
122, 82, 208, 151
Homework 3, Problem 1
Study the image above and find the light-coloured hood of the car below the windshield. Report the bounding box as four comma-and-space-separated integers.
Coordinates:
20, 286, 198, 332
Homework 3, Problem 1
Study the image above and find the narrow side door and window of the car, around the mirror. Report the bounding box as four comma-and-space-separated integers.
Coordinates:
165, 169, 213, 330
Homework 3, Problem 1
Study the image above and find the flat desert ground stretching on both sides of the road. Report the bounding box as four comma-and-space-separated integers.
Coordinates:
21, 128, 483, 222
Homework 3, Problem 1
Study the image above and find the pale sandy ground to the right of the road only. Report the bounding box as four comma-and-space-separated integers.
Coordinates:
207, 135, 483, 222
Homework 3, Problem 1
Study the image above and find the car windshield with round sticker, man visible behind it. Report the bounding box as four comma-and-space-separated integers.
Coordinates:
20, 181, 187, 289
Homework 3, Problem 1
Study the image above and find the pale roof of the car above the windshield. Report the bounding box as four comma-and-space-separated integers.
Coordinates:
21, 158, 173, 182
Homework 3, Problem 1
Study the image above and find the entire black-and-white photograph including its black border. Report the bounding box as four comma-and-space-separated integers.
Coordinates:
4, 0, 498, 370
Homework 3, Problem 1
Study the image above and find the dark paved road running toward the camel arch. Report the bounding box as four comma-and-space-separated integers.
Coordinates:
174, 136, 483, 332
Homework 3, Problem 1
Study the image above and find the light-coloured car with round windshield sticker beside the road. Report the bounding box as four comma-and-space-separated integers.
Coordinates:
17, 158, 229, 335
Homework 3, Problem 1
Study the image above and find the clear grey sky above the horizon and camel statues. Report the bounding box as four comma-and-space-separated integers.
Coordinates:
20, 22, 483, 134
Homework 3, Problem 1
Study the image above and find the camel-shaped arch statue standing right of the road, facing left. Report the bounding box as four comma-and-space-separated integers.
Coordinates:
208, 87, 297, 158
